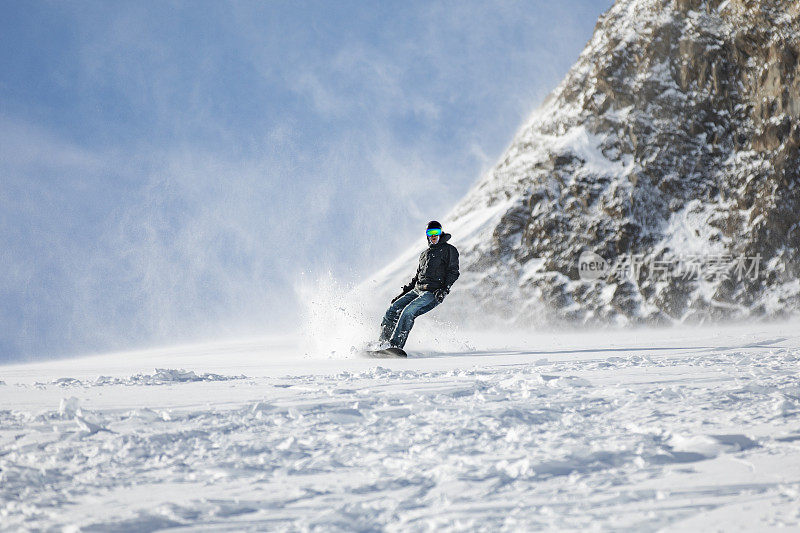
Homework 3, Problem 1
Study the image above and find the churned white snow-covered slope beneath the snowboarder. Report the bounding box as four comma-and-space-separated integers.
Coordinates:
0, 323, 800, 531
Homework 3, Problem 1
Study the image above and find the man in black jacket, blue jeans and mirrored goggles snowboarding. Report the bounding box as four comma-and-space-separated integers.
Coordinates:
380, 220, 458, 350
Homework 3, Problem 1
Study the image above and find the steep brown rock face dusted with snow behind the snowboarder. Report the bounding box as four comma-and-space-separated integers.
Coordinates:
438, 0, 800, 324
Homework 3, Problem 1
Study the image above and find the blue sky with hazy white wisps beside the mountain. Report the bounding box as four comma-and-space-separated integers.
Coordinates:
0, 0, 610, 361
